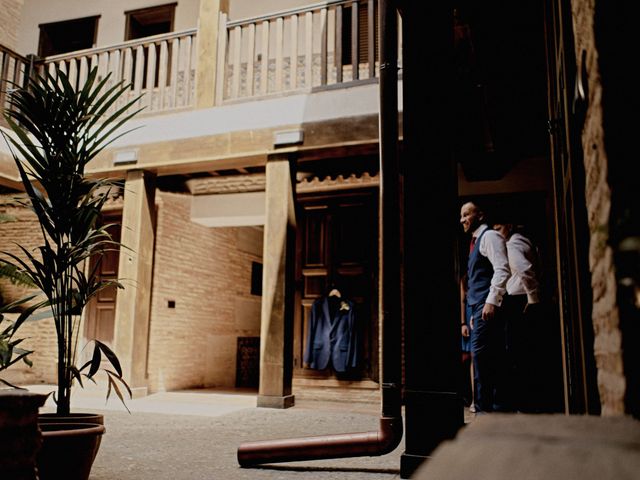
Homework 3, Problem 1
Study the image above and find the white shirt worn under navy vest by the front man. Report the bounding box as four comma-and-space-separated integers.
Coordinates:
473, 224, 511, 307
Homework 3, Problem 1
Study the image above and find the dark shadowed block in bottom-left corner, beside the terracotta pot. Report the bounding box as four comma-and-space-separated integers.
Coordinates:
0, 390, 47, 480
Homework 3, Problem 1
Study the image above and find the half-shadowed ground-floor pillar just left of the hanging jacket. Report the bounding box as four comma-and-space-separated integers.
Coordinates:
258, 155, 296, 408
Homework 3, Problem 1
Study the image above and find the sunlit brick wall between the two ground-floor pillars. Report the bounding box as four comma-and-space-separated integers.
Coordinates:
148, 192, 261, 392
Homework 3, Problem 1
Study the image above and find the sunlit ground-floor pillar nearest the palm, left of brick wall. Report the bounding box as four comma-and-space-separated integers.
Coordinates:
114, 170, 155, 394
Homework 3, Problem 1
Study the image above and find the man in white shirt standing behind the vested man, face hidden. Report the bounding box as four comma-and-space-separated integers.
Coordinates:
493, 223, 540, 411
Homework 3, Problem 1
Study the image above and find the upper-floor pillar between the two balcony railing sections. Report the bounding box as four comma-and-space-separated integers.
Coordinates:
196, 0, 229, 108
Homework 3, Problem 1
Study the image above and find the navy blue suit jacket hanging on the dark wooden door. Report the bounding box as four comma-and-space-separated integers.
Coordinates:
303, 297, 358, 372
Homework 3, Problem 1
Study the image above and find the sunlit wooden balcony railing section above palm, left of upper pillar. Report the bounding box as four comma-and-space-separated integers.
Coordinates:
40, 29, 197, 112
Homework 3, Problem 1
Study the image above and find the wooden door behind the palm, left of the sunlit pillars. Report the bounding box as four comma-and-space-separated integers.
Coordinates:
84, 217, 121, 344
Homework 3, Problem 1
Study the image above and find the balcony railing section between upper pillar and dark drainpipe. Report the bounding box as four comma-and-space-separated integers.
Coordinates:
216, 0, 400, 103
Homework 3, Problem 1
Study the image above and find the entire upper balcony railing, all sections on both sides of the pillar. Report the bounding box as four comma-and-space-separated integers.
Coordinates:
0, 0, 400, 114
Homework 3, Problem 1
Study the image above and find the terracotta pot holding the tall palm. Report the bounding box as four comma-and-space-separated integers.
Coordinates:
36, 422, 105, 480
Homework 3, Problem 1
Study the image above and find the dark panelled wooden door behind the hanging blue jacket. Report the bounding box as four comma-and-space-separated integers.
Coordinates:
293, 190, 378, 381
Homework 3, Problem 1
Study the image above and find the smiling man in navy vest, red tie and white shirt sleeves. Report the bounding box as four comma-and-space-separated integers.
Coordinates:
460, 202, 511, 412
